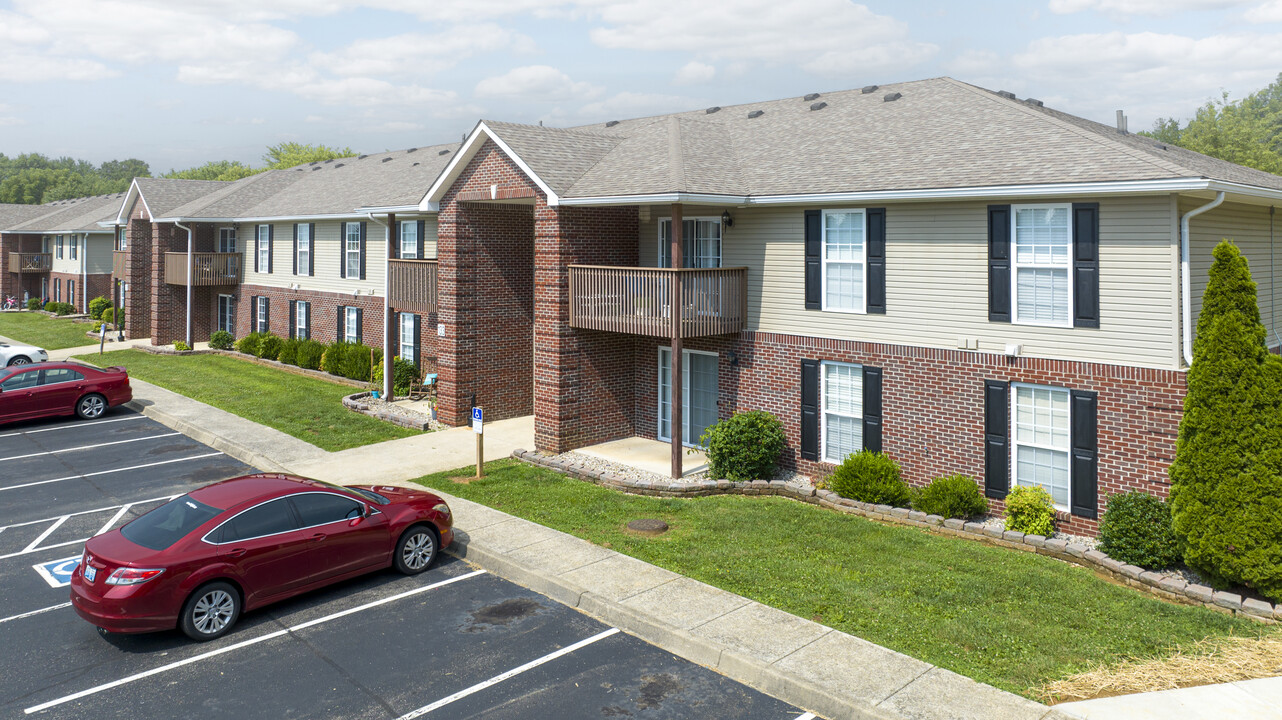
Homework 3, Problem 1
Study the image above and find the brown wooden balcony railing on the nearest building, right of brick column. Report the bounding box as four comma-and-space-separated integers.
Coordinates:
569, 265, 747, 338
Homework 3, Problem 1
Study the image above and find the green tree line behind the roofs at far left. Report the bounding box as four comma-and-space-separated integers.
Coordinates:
0, 142, 356, 205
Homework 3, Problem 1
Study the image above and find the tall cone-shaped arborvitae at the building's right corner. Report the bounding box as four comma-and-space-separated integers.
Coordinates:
1170, 241, 1282, 600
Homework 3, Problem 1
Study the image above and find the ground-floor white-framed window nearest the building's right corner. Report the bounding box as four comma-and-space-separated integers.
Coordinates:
1010, 383, 1072, 510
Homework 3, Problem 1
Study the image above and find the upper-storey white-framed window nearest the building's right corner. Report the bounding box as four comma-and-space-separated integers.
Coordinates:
1010, 204, 1073, 328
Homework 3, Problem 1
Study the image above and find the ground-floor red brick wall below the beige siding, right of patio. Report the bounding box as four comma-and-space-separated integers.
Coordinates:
635, 333, 1186, 534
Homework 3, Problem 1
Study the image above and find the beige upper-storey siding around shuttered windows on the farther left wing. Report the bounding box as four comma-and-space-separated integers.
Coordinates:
236, 220, 387, 296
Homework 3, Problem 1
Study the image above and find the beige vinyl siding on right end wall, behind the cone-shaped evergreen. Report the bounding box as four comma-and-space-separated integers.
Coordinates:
1179, 199, 1282, 347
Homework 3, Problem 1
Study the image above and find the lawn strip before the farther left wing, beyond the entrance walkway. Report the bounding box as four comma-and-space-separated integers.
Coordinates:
73, 350, 419, 451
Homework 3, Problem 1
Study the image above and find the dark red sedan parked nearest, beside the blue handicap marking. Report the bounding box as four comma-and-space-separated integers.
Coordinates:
72, 474, 454, 641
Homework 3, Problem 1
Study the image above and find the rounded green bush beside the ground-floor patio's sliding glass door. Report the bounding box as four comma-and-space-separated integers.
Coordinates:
699, 410, 787, 480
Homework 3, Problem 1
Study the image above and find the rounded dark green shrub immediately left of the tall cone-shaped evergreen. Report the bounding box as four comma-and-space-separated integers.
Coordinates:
1100, 491, 1179, 570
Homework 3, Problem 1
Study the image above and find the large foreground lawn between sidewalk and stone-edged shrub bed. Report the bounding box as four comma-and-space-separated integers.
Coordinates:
418, 460, 1268, 697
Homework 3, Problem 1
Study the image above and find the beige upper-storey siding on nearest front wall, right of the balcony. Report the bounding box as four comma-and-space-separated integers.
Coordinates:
640, 195, 1177, 368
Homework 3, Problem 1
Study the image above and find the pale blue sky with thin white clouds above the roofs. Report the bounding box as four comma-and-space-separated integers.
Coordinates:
0, 0, 1282, 173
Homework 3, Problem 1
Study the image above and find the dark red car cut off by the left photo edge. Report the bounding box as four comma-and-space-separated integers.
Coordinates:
0, 363, 133, 423
